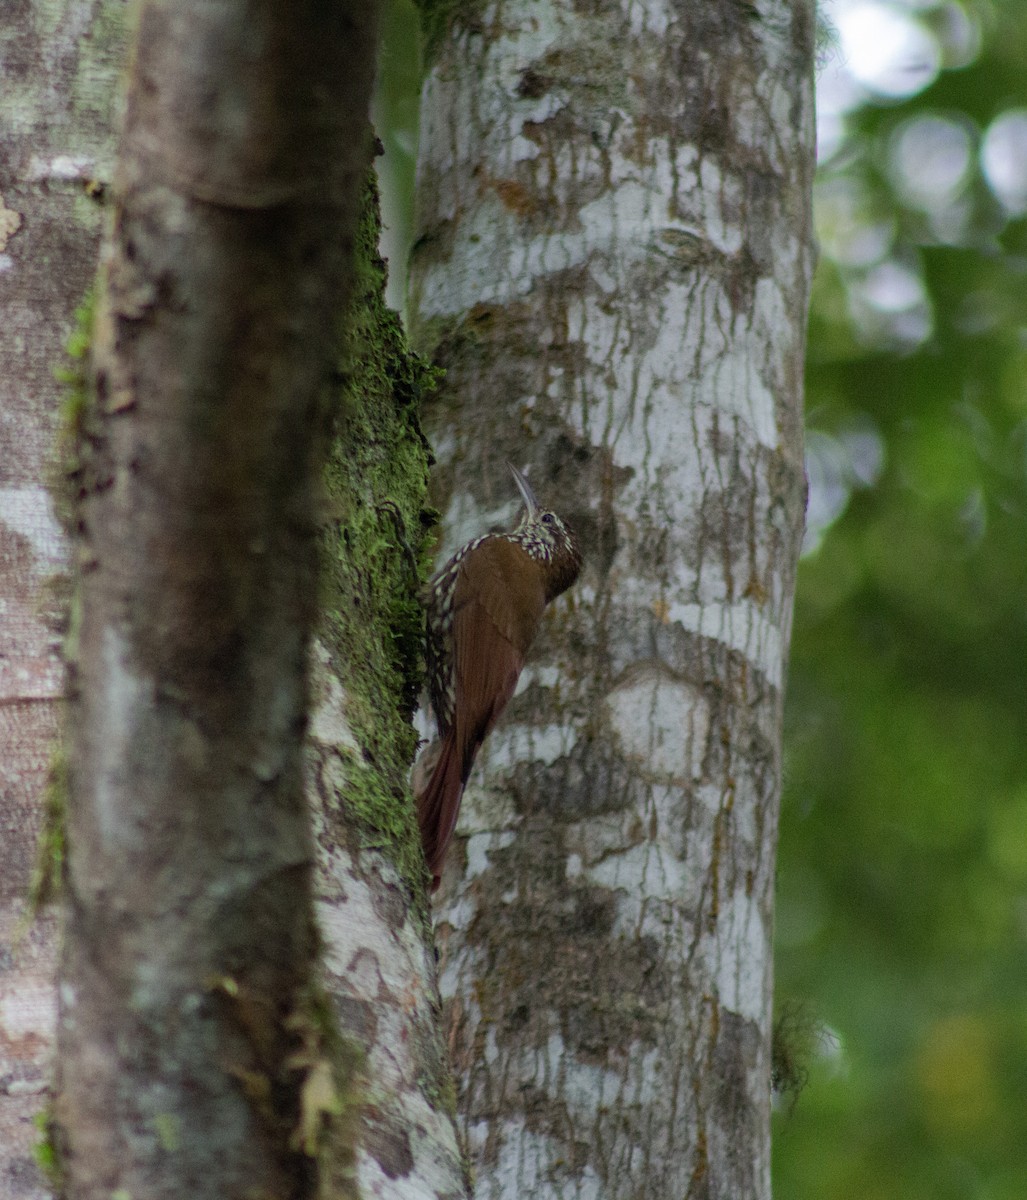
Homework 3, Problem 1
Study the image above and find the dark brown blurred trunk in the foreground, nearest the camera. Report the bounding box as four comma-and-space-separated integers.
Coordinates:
55, 0, 374, 1200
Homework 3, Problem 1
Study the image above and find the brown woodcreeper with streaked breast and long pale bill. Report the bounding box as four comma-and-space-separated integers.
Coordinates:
418, 466, 582, 890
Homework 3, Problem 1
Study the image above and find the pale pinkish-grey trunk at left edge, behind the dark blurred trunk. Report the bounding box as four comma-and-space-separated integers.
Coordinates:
0, 0, 126, 1200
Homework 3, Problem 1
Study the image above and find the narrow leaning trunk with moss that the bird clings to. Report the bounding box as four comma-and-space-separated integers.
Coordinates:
307, 188, 467, 1200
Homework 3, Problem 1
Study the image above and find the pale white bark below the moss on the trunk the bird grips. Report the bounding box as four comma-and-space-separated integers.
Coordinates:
307, 642, 467, 1200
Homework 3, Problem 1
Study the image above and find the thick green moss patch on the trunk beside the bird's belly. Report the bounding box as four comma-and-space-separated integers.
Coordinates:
320, 166, 438, 881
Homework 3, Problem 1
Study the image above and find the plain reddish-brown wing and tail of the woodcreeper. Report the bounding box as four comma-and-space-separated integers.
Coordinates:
418, 538, 545, 887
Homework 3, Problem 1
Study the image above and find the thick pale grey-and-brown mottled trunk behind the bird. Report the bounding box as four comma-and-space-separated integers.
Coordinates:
412, 0, 813, 1200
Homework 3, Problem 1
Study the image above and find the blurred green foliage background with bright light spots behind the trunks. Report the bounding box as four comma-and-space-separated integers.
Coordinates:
377, 0, 1027, 1200
